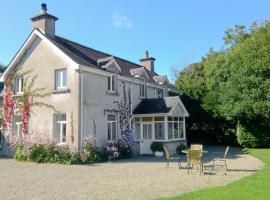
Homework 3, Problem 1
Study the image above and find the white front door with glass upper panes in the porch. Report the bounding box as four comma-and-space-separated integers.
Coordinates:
140, 123, 153, 154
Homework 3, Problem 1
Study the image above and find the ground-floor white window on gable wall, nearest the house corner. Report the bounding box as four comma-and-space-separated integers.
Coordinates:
54, 113, 67, 143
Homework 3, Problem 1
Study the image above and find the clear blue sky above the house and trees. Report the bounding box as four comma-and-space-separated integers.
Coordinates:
0, 0, 270, 80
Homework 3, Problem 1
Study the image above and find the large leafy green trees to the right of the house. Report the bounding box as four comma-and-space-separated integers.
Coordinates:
176, 22, 270, 147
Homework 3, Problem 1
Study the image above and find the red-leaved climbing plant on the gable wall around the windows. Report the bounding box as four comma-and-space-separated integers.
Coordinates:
2, 70, 57, 136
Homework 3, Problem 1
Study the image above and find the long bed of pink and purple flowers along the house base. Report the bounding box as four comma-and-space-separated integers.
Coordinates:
8, 132, 135, 164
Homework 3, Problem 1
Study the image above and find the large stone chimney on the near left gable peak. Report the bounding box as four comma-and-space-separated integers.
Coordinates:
31, 3, 58, 37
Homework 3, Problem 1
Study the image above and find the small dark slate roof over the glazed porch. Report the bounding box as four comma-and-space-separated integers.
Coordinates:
133, 96, 179, 115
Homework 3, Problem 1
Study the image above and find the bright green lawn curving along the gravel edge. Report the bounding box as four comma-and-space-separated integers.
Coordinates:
159, 149, 270, 200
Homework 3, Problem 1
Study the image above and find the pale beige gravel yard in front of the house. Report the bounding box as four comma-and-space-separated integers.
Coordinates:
0, 148, 263, 200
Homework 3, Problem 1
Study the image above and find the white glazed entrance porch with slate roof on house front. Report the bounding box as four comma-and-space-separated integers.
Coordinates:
133, 96, 189, 154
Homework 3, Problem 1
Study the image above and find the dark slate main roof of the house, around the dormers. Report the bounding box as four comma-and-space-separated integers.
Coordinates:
46, 36, 158, 83
